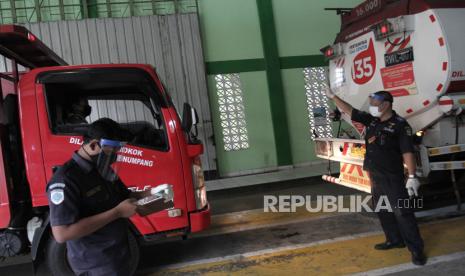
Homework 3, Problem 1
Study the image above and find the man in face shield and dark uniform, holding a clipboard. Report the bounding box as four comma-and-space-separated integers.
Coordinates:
47, 118, 136, 276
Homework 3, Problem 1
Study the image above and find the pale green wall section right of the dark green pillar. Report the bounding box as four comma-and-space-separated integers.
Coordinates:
273, 0, 360, 165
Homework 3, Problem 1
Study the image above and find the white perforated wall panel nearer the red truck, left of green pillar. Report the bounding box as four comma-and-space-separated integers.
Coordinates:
215, 74, 249, 151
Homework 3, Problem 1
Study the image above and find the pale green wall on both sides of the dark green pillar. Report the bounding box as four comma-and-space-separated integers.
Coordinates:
199, 0, 361, 175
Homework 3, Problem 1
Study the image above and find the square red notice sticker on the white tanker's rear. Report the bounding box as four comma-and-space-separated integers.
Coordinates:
381, 62, 417, 97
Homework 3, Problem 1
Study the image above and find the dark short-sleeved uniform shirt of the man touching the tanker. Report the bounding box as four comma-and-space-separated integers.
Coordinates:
352, 109, 414, 175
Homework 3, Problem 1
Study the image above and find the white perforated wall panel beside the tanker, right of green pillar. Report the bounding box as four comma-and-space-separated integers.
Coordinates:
304, 67, 332, 139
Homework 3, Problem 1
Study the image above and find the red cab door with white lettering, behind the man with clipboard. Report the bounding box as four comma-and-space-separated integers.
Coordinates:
36, 68, 188, 234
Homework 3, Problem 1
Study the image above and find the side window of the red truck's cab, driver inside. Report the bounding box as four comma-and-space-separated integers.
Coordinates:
44, 69, 168, 151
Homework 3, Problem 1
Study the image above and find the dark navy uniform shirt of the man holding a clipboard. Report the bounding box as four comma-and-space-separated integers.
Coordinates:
47, 153, 129, 275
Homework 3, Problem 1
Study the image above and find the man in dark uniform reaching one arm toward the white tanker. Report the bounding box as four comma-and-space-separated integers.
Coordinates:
326, 89, 426, 265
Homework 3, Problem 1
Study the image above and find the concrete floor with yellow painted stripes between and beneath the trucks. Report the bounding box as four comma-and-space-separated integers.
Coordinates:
0, 178, 465, 276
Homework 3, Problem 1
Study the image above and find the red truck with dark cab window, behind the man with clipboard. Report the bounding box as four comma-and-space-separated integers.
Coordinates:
0, 25, 210, 275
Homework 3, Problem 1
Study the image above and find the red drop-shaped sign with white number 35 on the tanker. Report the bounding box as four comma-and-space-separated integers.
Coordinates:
352, 39, 376, 85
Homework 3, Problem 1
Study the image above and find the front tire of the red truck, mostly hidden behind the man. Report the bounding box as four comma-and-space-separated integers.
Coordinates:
45, 232, 140, 276
